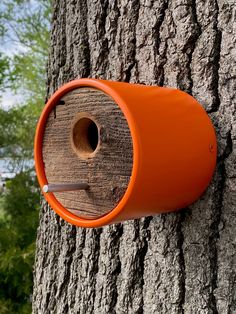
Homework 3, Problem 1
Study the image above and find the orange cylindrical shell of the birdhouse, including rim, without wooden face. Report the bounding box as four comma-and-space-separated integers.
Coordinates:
35, 79, 217, 227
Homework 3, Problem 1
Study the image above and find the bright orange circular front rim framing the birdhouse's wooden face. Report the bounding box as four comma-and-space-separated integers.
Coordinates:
34, 78, 139, 228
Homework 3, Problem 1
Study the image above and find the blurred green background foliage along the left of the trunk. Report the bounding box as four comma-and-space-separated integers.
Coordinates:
0, 0, 51, 314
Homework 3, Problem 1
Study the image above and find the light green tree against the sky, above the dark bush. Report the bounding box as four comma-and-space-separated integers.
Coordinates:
0, 0, 51, 166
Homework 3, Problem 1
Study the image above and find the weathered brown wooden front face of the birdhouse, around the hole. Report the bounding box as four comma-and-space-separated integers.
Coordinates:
43, 88, 133, 218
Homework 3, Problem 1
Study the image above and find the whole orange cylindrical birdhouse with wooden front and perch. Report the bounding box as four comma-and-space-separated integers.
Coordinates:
35, 79, 217, 227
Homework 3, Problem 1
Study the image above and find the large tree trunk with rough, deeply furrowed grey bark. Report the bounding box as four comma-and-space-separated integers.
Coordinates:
33, 0, 236, 314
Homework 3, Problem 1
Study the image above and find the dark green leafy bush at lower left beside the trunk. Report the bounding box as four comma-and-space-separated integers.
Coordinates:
0, 172, 39, 314
